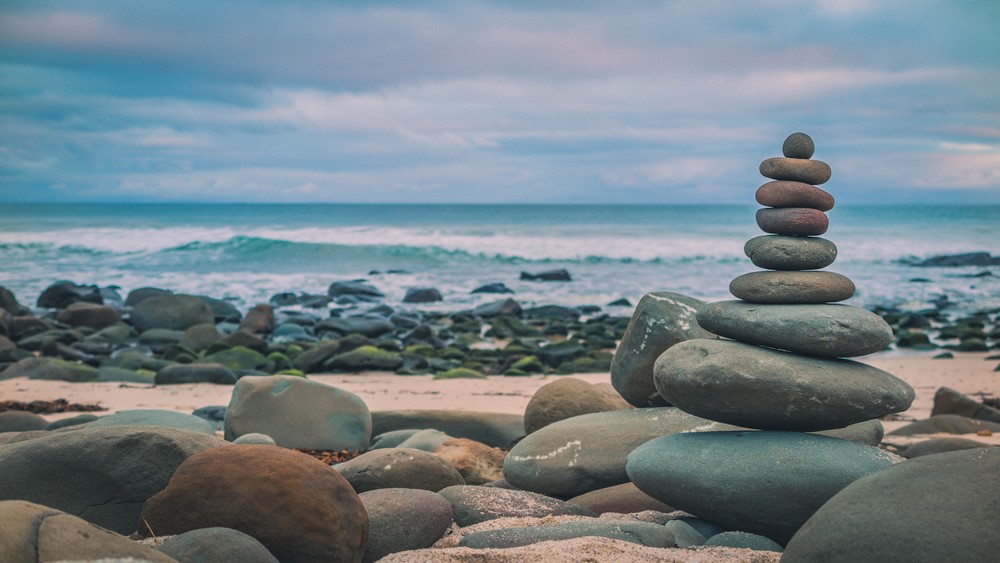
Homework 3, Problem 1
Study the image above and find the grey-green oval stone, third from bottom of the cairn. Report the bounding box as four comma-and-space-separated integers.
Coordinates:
698, 301, 893, 358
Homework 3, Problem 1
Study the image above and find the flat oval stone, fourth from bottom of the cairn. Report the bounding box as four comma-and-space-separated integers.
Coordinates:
729, 272, 855, 303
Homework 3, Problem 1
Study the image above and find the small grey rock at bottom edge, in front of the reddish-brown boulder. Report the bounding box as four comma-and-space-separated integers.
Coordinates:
157, 527, 278, 563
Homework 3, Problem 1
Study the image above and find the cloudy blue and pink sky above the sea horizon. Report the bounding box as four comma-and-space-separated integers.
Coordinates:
0, 0, 1000, 204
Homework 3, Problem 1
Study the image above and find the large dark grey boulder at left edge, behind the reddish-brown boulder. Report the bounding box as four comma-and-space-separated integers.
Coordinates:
0, 426, 226, 532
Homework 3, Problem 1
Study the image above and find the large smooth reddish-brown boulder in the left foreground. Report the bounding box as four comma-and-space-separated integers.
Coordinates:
138, 445, 368, 561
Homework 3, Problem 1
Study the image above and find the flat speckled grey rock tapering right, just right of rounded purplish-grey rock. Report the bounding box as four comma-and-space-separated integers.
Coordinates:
439, 485, 597, 527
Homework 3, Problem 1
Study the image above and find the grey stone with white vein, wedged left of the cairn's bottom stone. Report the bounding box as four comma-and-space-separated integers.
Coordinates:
503, 407, 731, 498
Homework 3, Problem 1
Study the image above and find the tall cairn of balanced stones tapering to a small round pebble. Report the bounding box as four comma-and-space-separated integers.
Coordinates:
626, 133, 914, 545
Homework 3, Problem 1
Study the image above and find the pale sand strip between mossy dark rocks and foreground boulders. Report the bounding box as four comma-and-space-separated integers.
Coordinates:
0, 352, 1000, 445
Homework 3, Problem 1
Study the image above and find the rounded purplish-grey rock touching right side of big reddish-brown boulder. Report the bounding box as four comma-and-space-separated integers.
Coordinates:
358, 489, 451, 562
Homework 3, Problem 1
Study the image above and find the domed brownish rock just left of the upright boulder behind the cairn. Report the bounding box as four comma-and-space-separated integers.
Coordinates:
524, 377, 632, 434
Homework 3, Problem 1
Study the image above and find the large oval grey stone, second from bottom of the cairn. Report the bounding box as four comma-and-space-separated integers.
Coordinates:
654, 340, 914, 432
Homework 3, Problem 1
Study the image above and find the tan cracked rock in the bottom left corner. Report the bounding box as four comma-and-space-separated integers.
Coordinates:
0, 500, 174, 563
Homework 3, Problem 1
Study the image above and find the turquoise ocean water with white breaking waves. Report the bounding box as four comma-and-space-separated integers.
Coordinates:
0, 204, 1000, 314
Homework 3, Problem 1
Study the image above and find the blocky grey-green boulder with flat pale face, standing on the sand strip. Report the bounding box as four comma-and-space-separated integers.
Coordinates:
223, 375, 372, 450
